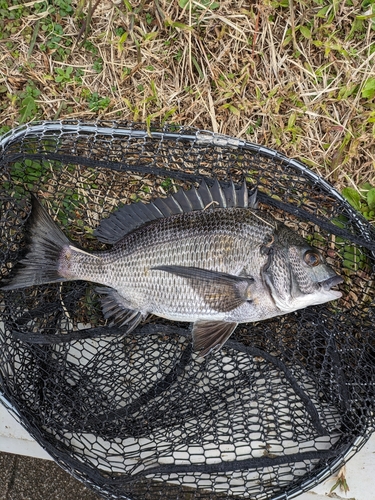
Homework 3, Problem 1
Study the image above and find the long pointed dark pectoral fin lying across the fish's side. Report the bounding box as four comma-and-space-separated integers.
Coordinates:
152, 266, 254, 312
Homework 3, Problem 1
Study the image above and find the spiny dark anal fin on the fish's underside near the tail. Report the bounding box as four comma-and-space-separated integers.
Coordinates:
95, 287, 148, 333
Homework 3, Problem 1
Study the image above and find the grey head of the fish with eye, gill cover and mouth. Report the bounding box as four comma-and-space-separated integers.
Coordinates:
262, 230, 344, 313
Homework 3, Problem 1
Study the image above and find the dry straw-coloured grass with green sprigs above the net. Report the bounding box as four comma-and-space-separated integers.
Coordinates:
0, 0, 375, 189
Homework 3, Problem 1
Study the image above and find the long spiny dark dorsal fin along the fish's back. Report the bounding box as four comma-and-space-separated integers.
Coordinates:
94, 179, 258, 244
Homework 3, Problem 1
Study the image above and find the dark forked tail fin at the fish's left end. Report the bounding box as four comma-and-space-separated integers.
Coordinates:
2, 195, 70, 290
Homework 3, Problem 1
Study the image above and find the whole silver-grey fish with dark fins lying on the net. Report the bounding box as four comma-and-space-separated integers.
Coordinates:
2, 180, 343, 356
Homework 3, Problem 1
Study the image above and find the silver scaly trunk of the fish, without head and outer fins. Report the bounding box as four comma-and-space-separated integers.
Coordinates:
64, 208, 275, 322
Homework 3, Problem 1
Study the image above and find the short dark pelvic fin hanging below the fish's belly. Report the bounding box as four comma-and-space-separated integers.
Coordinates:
193, 321, 238, 356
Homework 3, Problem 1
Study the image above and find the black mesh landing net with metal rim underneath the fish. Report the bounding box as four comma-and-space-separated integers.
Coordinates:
0, 121, 375, 500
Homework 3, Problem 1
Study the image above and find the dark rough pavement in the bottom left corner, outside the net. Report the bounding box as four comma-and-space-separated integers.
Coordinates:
0, 453, 100, 500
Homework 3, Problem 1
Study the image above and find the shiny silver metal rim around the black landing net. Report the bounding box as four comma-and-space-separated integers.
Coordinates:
0, 119, 372, 500
